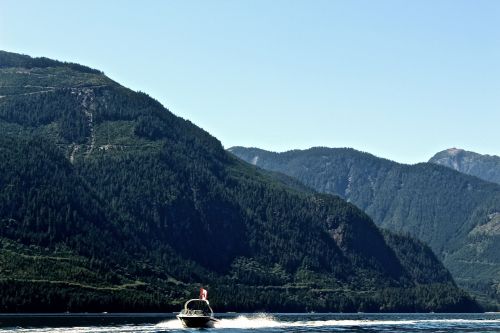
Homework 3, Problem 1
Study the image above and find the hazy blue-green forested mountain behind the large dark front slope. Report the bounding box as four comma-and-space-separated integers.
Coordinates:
229, 147, 500, 304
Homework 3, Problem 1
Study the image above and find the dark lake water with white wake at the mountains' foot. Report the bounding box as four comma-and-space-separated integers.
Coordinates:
0, 313, 500, 333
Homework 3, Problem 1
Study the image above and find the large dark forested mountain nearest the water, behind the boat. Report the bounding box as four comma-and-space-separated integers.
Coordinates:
0, 52, 478, 312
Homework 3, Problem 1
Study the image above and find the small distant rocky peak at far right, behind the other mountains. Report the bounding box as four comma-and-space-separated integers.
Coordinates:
429, 148, 500, 184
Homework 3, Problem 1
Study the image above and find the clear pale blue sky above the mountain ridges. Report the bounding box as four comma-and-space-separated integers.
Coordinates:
0, 0, 500, 163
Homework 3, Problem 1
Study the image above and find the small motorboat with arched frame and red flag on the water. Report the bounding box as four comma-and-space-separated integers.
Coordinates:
177, 288, 217, 328
